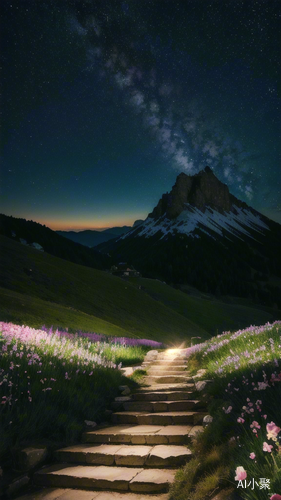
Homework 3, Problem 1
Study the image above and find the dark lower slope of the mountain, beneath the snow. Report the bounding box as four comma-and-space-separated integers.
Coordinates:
96, 219, 281, 309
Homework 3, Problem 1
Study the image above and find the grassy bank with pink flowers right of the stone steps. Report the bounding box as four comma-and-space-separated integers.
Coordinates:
170, 321, 281, 500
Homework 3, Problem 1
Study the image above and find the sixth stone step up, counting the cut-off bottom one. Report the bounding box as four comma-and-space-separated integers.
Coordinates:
122, 399, 202, 412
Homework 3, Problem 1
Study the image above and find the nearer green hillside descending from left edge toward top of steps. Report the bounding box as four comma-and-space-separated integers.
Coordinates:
0, 236, 208, 343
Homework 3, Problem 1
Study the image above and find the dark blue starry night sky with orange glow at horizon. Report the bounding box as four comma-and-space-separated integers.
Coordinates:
0, 0, 281, 230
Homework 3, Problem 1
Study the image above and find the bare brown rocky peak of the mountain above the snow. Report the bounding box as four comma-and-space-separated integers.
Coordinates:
149, 166, 247, 219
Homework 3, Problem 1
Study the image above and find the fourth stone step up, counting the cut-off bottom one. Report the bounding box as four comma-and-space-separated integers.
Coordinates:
82, 424, 203, 445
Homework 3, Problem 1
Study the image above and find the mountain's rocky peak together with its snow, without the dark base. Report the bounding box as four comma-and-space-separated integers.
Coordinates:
120, 167, 270, 243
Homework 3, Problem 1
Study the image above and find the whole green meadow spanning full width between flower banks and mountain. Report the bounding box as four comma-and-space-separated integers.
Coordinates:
0, 236, 281, 346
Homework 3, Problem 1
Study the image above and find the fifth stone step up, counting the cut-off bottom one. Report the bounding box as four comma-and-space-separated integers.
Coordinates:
111, 411, 206, 425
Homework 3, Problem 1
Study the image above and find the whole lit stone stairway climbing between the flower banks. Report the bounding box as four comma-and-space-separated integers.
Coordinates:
14, 350, 206, 500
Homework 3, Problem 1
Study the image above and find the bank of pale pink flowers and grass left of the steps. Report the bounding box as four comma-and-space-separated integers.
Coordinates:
0, 322, 160, 465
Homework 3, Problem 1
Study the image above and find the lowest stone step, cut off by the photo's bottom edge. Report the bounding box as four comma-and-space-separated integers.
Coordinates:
16, 488, 169, 500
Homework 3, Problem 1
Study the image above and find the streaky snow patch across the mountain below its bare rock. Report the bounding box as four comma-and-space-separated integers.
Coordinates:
120, 203, 269, 239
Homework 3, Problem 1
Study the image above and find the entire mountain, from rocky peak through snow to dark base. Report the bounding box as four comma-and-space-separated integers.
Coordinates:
97, 167, 281, 307
